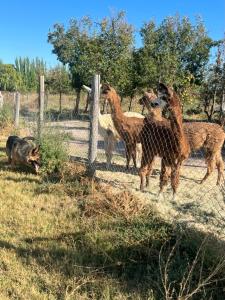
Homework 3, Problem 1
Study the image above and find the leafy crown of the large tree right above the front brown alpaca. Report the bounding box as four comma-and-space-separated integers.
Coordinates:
135, 15, 214, 93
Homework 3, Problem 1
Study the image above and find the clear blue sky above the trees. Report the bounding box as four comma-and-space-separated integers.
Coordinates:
0, 0, 225, 67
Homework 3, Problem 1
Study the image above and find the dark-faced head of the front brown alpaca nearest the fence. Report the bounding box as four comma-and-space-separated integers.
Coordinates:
151, 83, 174, 109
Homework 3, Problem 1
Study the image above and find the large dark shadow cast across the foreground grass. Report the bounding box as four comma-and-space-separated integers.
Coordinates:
0, 220, 225, 300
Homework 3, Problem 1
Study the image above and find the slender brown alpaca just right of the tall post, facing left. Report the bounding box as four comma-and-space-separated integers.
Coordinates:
102, 84, 144, 169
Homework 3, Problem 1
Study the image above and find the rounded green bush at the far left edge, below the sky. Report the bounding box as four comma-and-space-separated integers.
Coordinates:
0, 64, 23, 92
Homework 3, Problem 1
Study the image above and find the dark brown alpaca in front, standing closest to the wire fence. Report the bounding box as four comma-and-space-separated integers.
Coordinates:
139, 83, 190, 197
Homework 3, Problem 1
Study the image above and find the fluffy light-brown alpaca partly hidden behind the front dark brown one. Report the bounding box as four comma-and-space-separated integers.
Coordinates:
139, 90, 225, 185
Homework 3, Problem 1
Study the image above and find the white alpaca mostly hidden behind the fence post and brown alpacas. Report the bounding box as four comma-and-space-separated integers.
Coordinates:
83, 85, 144, 169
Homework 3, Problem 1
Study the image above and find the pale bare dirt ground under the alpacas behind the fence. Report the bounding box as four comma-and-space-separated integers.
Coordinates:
34, 121, 225, 238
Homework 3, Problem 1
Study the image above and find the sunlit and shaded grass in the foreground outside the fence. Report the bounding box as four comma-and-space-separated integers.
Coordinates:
0, 137, 225, 300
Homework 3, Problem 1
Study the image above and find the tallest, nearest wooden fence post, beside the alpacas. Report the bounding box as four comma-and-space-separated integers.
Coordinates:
88, 75, 100, 177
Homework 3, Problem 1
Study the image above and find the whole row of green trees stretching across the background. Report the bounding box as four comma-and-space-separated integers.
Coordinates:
0, 12, 225, 119
